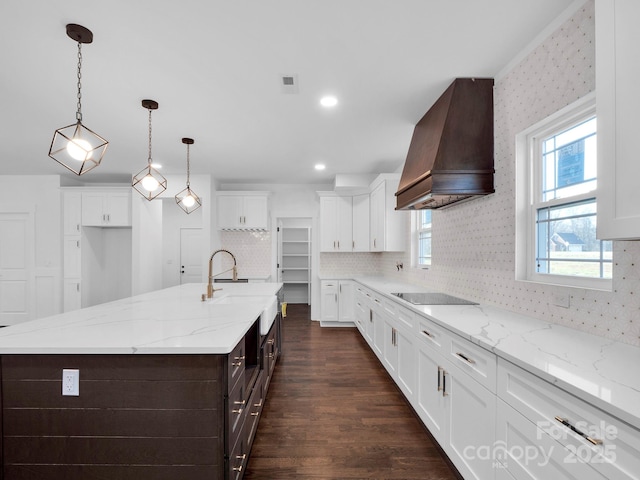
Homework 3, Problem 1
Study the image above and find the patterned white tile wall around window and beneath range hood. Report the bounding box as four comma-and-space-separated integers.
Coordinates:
321, 1, 640, 346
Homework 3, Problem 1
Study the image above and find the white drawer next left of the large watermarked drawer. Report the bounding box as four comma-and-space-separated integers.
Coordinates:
449, 334, 497, 393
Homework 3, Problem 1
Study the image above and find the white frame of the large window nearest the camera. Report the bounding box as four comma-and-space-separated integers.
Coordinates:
515, 93, 612, 291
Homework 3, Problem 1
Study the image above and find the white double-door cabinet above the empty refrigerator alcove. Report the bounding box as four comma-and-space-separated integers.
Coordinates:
82, 188, 131, 227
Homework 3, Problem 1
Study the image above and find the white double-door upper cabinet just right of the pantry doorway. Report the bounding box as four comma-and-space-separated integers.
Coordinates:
320, 196, 353, 252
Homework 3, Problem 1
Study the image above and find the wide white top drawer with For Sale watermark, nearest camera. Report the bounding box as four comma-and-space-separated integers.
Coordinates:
498, 359, 640, 480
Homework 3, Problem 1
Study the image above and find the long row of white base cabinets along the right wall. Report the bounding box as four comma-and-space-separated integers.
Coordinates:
353, 281, 640, 480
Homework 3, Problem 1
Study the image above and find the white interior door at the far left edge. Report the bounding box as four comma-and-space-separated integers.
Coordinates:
0, 212, 33, 325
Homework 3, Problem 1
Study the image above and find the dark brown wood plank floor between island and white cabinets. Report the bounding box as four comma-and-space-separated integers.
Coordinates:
244, 305, 459, 480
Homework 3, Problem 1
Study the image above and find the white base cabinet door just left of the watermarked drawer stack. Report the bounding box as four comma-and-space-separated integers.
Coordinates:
443, 362, 498, 480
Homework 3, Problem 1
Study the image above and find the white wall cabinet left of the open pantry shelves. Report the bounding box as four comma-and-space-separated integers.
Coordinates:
216, 191, 269, 230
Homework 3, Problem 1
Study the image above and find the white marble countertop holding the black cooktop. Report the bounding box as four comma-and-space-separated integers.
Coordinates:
355, 277, 640, 428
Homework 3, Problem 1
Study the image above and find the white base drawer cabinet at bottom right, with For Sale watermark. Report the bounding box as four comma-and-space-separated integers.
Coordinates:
497, 359, 640, 480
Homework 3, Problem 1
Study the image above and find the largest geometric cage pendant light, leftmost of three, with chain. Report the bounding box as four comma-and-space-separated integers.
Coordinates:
49, 23, 109, 175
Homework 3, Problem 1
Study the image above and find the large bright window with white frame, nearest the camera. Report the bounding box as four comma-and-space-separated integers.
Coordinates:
516, 96, 612, 288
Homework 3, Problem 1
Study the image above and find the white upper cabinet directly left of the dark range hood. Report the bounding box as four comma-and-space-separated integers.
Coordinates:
369, 175, 408, 252
